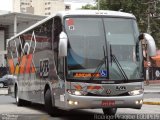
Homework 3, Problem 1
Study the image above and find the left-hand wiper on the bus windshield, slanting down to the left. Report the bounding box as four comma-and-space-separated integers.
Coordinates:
90, 46, 108, 80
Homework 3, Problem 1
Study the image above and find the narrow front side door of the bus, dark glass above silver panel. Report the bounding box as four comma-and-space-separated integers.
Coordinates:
53, 17, 65, 107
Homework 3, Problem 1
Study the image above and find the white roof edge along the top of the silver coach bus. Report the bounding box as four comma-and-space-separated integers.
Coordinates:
7, 10, 136, 45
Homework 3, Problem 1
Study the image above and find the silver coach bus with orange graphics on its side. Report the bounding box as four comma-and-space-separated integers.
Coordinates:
7, 10, 156, 115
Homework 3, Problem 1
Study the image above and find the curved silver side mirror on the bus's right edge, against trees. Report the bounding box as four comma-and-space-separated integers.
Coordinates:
139, 33, 156, 57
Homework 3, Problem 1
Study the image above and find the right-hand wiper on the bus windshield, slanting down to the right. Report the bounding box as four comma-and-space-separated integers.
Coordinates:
110, 45, 128, 80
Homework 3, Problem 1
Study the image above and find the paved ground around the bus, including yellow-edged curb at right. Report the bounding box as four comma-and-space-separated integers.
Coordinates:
0, 84, 160, 120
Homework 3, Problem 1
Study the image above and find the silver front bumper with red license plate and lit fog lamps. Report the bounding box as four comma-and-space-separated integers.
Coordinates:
66, 94, 143, 109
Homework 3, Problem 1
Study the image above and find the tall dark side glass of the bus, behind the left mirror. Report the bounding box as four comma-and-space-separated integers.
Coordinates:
53, 17, 64, 79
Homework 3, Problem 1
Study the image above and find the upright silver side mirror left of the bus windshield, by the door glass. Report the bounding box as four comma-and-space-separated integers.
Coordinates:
58, 31, 67, 57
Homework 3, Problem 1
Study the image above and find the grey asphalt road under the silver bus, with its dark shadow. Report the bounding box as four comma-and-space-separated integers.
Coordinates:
0, 95, 160, 120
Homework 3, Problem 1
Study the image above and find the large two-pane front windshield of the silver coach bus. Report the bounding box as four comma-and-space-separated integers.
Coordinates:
65, 17, 142, 80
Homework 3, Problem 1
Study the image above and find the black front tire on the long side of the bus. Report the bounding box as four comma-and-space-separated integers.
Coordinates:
44, 89, 59, 116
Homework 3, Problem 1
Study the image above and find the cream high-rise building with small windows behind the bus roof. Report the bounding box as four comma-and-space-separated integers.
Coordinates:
13, 0, 65, 15
